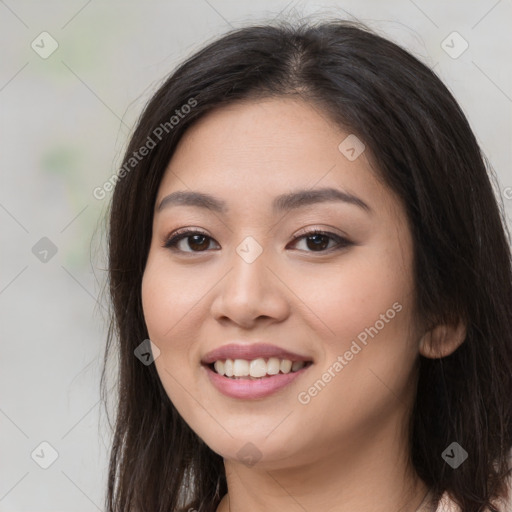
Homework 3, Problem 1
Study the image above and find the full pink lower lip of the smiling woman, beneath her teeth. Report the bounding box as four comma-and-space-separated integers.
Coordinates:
203, 364, 311, 399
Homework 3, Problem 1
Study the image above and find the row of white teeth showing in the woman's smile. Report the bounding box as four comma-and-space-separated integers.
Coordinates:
213, 357, 306, 379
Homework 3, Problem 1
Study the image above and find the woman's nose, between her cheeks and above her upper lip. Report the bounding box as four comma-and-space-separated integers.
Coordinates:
211, 245, 290, 329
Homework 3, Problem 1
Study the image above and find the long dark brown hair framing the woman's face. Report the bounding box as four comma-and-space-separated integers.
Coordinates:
102, 21, 512, 512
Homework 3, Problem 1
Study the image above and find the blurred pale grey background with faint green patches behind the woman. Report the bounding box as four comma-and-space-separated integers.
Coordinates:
0, 0, 512, 512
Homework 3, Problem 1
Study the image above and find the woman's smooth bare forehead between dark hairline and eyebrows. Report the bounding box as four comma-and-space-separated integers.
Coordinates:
155, 98, 396, 218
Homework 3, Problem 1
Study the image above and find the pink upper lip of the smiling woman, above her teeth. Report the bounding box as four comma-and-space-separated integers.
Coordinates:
201, 343, 311, 364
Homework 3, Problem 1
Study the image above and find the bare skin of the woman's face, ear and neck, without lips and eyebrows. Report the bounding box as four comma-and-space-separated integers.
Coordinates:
142, 98, 464, 512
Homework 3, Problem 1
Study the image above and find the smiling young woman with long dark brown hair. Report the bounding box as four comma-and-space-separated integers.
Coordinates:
102, 21, 512, 512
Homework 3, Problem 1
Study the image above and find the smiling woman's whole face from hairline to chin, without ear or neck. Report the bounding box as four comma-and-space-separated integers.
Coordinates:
142, 98, 419, 468
